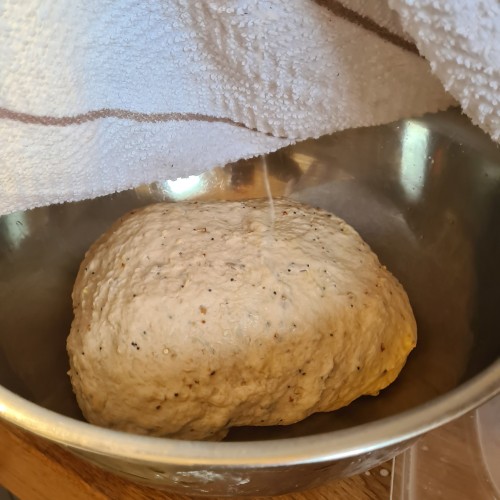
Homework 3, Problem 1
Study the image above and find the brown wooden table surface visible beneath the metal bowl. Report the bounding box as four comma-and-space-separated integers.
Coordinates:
0, 420, 391, 500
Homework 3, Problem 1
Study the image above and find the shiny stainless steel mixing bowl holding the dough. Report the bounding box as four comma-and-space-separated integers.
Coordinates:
0, 111, 500, 495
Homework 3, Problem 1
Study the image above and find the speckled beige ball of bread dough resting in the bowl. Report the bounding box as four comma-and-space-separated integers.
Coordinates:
67, 199, 416, 439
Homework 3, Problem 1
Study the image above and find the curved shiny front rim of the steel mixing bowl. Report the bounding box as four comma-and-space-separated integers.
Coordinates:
0, 359, 500, 469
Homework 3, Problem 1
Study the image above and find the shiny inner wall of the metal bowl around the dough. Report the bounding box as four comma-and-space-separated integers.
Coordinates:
0, 112, 500, 440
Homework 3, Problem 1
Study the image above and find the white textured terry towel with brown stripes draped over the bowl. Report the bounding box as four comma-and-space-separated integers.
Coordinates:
0, 0, 500, 213
